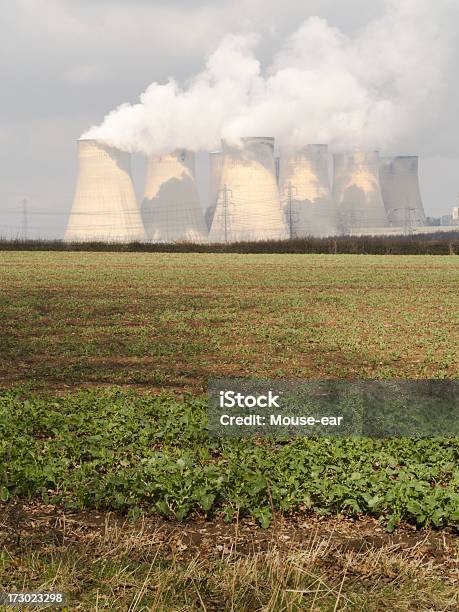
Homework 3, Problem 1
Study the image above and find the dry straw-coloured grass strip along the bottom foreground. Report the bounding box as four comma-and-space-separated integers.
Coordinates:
0, 515, 459, 612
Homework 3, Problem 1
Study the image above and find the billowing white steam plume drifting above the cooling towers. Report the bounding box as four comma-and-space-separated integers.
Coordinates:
82, 0, 457, 155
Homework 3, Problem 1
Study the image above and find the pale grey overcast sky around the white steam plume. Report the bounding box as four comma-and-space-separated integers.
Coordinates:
0, 0, 459, 236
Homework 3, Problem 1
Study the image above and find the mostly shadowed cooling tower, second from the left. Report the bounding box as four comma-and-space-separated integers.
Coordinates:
142, 150, 207, 242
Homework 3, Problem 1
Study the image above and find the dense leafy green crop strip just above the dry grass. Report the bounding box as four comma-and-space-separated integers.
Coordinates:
0, 388, 459, 529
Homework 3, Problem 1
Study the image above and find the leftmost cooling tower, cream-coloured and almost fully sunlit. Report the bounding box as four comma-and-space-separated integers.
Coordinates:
64, 140, 146, 242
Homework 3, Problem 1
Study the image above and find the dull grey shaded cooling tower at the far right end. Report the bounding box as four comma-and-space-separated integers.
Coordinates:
379, 156, 426, 227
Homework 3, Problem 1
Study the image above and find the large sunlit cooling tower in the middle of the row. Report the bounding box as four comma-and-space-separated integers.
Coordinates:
209, 138, 288, 242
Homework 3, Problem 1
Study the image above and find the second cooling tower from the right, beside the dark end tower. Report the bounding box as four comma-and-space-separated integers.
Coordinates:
333, 151, 388, 233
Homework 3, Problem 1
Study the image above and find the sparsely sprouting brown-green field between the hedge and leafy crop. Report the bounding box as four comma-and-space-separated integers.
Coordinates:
0, 252, 459, 393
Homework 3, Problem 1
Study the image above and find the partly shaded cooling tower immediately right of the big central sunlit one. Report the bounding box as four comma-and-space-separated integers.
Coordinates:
279, 145, 339, 238
